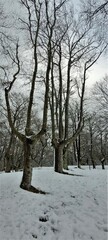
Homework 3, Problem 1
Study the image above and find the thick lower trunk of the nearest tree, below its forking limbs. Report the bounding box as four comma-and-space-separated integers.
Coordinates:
20, 139, 32, 191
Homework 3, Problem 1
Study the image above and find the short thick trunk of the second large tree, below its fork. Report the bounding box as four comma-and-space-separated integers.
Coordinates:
55, 144, 63, 173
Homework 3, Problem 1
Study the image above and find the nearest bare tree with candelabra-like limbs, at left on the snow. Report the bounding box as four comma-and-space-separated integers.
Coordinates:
1, 0, 65, 193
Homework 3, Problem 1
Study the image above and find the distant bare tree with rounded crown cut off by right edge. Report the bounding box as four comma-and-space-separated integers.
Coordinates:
93, 75, 108, 167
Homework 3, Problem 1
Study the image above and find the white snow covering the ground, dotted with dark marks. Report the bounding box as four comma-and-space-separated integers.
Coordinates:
0, 167, 108, 240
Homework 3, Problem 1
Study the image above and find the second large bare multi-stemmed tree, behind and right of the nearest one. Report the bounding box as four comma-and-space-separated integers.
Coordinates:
50, 4, 106, 173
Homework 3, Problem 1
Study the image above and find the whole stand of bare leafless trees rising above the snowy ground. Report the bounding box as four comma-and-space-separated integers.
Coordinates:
0, 0, 108, 192
